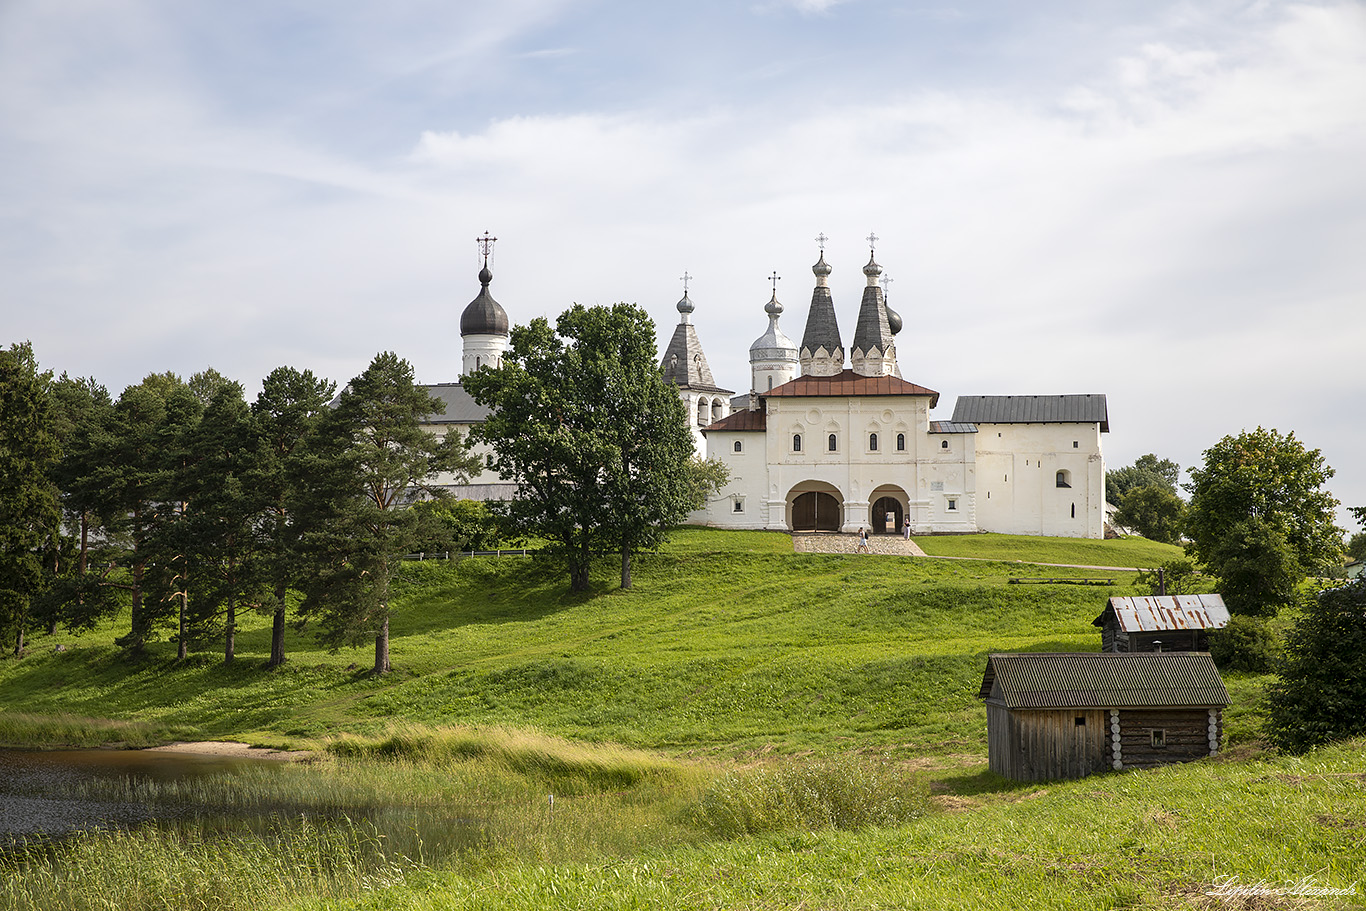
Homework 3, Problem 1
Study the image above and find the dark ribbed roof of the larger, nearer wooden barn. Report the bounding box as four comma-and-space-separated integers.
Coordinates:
978, 651, 1228, 709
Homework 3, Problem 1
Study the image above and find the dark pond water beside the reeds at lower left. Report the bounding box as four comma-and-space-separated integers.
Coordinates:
0, 750, 277, 845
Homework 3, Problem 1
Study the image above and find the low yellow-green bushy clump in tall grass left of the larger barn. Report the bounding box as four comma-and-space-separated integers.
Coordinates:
697, 757, 929, 839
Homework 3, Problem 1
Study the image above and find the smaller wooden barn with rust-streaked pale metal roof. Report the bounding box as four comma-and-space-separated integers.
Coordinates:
1091, 594, 1228, 651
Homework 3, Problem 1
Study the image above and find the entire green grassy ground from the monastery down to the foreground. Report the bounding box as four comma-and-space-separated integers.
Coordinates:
0, 529, 1366, 911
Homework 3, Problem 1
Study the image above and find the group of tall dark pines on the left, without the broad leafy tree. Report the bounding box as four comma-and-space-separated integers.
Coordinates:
0, 344, 479, 672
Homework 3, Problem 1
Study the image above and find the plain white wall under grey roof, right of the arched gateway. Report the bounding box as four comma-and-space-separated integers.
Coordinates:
975, 423, 1105, 538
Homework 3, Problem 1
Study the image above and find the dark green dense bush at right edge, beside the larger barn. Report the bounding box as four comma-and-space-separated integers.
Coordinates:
1266, 579, 1366, 753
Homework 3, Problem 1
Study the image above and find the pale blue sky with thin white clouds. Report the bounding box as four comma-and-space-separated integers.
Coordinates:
0, 0, 1366, 530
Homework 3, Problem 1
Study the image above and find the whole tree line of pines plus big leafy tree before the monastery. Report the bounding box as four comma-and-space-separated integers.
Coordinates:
0, 303, 727, 673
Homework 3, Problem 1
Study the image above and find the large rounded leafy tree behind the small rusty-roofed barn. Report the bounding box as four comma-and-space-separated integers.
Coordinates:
1186, 428, 1341, 616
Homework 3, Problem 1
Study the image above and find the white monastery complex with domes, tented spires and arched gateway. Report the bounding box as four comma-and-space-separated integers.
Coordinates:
425, 236, 1109, 538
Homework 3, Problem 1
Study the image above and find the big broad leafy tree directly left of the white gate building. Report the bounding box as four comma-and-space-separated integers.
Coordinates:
464, 303, 714, 591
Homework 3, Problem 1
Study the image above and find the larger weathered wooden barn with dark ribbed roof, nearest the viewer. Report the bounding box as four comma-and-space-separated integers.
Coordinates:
978, 651, 1228, 781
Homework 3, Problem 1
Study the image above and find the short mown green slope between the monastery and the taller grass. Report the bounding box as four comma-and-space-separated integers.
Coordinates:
0, 529, 1218, 761
